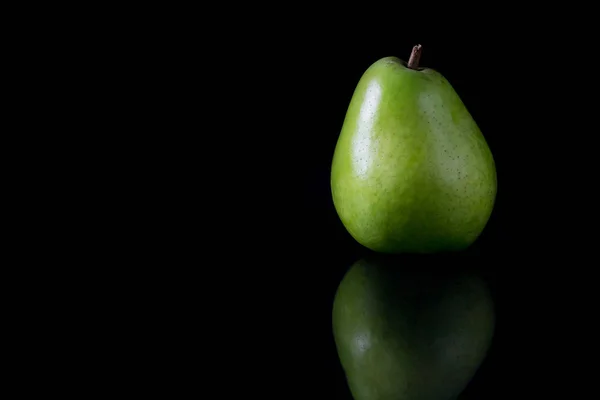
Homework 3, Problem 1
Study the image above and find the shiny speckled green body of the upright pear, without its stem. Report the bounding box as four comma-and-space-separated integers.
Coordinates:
331, 57, 497, 253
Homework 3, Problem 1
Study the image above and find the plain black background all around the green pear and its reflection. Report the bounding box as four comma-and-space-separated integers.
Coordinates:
14, 3, 598, 400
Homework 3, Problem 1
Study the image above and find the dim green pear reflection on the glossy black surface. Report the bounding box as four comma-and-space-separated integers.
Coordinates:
333, 255, 494, 400
